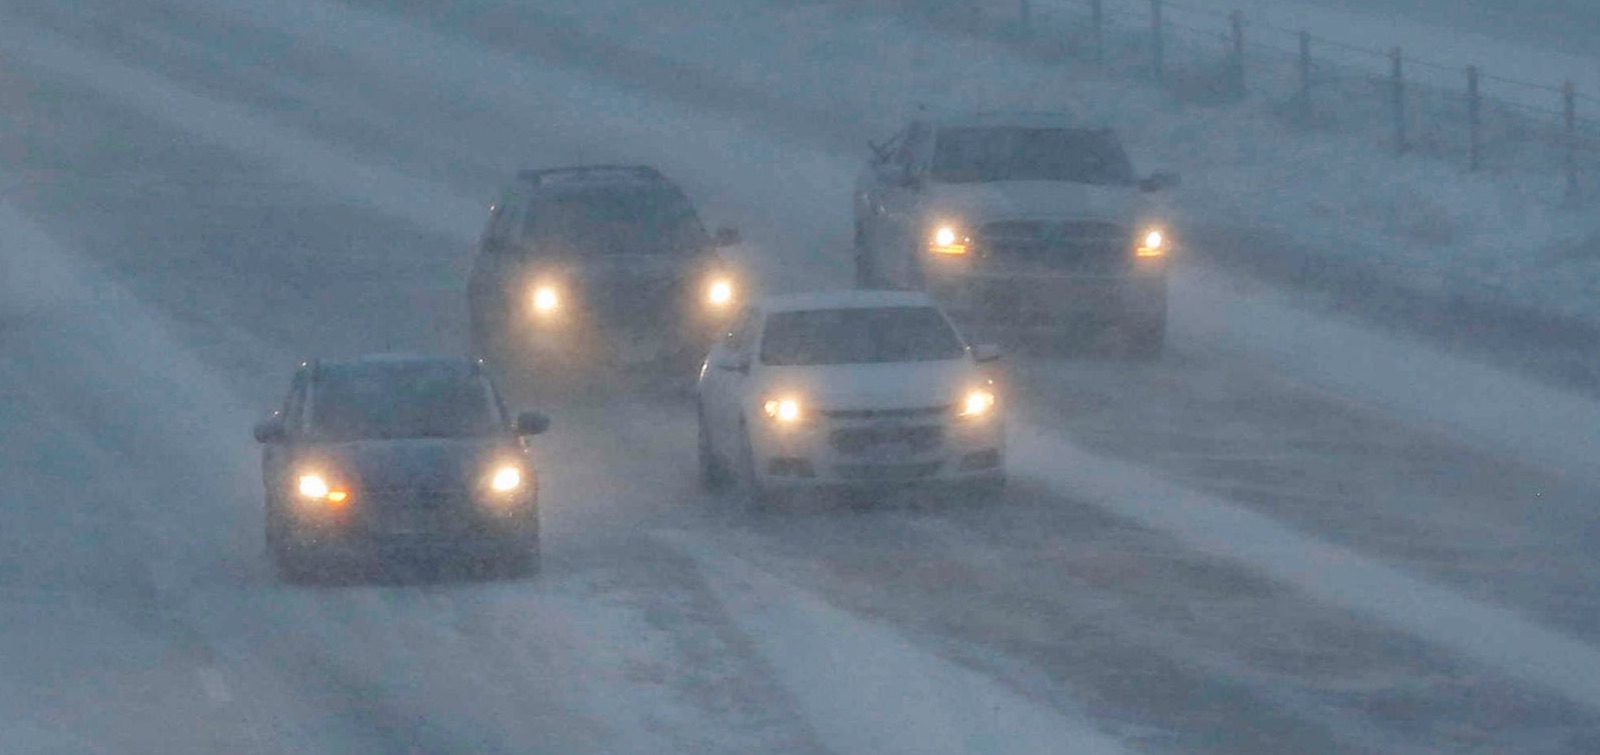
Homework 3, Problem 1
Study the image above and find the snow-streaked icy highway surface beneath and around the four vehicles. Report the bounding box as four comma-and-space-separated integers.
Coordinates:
0, 0, 1600, 753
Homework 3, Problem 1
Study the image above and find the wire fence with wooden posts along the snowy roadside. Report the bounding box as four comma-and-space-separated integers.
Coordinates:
909, 0, 1600, 202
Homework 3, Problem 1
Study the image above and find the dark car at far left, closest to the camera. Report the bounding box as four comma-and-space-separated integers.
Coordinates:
256, 355, 549, 579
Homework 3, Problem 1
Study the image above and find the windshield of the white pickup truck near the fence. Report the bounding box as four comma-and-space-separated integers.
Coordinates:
930, 126, 1134, 186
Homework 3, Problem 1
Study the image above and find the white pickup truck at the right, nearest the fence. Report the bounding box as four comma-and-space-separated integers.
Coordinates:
854, 114, 1178, 357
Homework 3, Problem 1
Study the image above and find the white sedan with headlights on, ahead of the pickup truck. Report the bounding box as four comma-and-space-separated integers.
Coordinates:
699, 291, 1005, 497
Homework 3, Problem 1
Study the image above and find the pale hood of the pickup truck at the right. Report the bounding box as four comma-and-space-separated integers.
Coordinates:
925, 181, 1146, 222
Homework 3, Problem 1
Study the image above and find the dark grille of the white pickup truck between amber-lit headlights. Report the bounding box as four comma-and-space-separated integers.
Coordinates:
978, 221, 1133, 275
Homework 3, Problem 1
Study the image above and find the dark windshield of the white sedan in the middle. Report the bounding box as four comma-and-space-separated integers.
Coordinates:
762, 307, 965, 366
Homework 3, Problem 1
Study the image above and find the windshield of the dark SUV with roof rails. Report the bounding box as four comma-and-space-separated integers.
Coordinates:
525, 187, 707, 254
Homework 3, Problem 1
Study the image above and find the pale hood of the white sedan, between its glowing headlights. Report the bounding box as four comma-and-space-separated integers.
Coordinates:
757, 360, 982, 411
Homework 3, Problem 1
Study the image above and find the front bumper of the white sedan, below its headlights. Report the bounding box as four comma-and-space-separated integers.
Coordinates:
750, 411, 1005, 489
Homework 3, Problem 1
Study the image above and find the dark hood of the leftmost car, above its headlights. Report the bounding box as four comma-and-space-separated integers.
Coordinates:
307, 438, 518, 489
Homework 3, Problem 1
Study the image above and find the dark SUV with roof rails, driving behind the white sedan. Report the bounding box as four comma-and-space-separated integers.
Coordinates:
467, 165, 746, 374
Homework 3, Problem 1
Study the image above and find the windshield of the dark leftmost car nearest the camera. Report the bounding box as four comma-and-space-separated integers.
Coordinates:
310, 363, 499, 441
